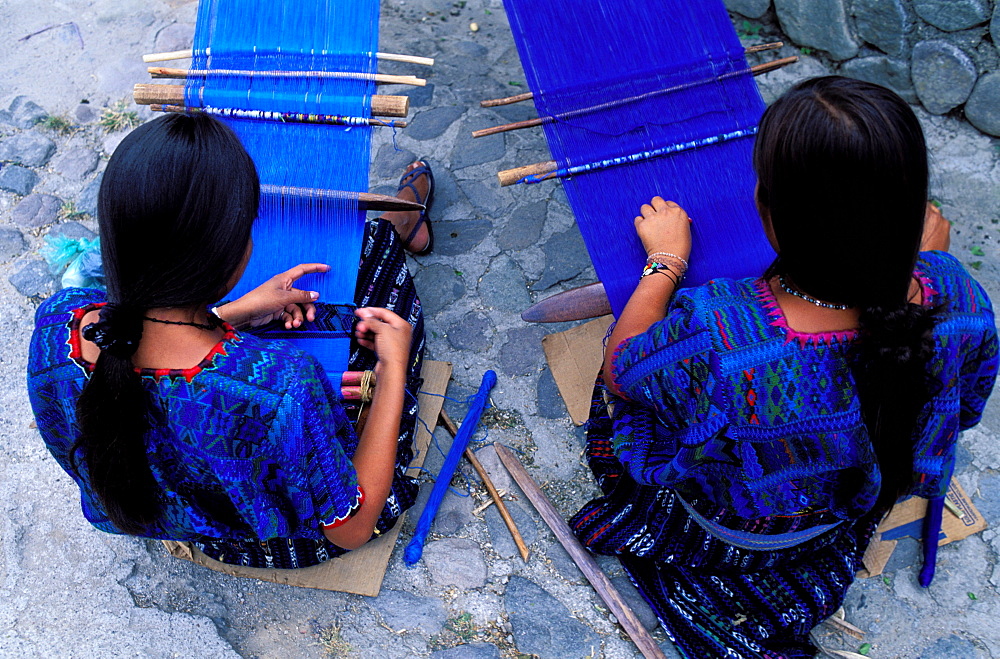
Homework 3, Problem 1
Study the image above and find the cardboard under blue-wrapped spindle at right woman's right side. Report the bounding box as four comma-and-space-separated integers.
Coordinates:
858, 478, 986, 577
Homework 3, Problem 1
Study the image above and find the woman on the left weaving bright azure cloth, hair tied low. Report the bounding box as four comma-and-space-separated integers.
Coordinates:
28, 115, 429, 568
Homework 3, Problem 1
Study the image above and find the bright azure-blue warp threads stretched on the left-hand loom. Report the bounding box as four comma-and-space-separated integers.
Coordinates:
185, 0, 379, 384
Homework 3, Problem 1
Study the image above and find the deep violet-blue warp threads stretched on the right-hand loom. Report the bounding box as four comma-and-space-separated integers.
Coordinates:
504, 0, 774, 315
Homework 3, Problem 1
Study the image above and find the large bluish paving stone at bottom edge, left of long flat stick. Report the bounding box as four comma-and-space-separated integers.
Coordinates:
504, 577, 601, 657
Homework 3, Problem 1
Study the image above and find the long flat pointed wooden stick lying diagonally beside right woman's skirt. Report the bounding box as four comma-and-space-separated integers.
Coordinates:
493, 443, 666, 659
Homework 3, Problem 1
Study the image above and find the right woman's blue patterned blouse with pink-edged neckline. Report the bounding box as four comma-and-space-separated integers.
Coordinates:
611, 252, 997, 526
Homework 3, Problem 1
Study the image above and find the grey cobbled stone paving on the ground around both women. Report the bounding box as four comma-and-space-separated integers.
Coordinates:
0, 0, 1000, 659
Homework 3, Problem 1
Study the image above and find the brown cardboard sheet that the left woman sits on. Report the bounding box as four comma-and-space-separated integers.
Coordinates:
163, 360, 451, 597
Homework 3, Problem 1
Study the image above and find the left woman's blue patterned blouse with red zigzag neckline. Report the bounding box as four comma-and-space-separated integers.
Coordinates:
28, 288, 359, 540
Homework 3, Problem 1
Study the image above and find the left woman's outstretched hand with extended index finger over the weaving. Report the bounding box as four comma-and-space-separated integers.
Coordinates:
217, 263, 330, 329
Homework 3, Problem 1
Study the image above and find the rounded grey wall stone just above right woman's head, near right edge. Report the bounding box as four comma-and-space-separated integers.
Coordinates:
910, 39, 978, 114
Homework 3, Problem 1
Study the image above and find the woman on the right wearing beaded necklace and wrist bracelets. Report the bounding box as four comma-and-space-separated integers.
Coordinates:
572, 77, 997, 659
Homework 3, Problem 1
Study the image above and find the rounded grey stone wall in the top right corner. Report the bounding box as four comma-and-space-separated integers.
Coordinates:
725, 0, 1000, 136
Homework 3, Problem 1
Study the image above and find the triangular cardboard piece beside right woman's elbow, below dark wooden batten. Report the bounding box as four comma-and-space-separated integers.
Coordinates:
542, 316, 614, 426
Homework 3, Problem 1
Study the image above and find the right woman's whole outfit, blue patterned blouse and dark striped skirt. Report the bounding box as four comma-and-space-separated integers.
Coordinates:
571, 252, 998, 659
